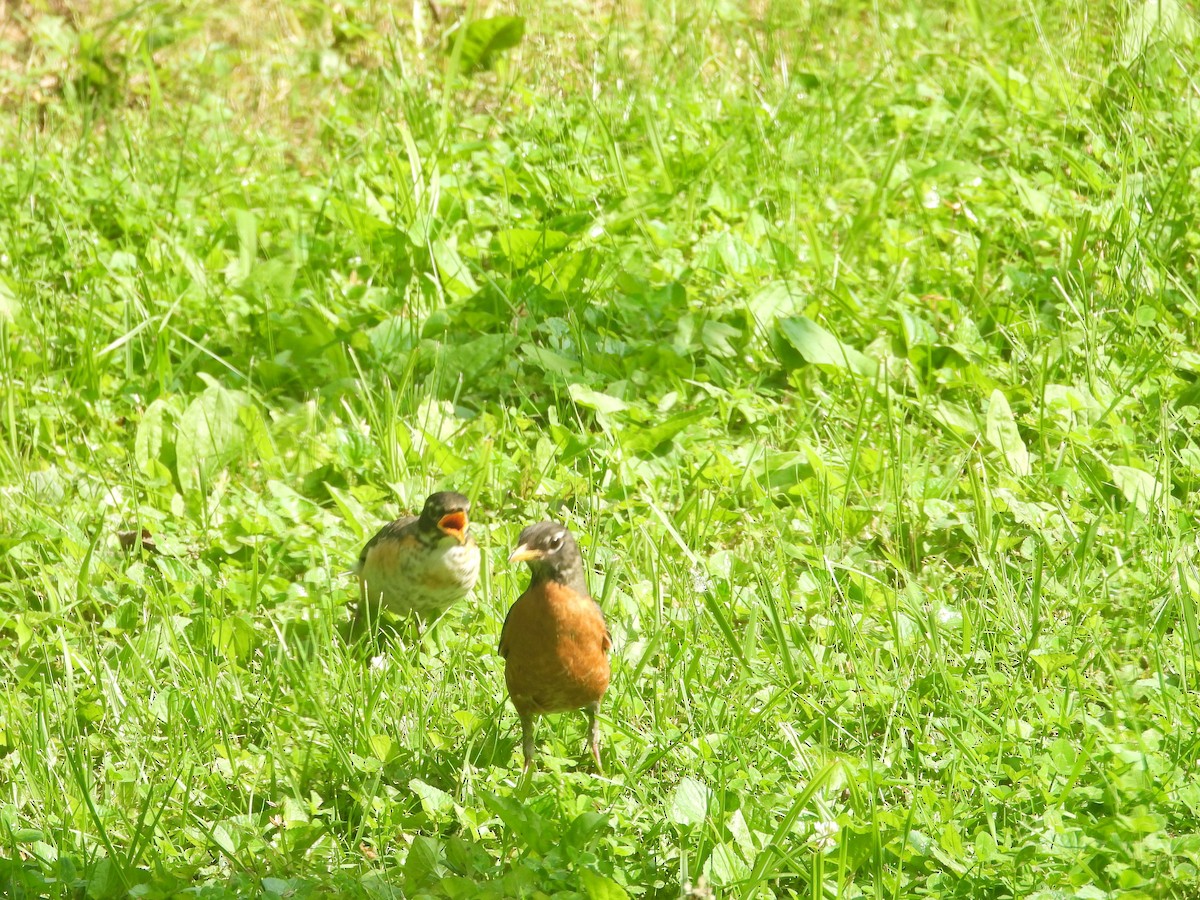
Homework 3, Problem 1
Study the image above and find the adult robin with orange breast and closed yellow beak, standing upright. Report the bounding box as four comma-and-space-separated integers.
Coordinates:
499, 522, 612, 772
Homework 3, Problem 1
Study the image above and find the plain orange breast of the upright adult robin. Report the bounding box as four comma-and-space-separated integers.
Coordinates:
500, 584, 612, 713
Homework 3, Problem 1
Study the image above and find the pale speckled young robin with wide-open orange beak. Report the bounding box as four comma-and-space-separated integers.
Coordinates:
353, 491, 479, 634
